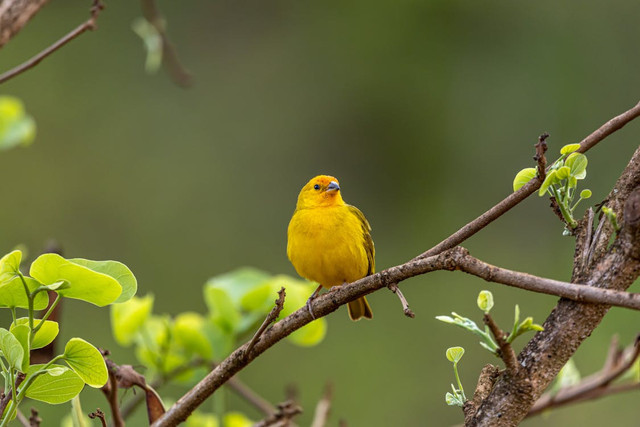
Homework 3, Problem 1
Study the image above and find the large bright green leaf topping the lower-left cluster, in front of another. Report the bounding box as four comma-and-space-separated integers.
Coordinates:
30, 254, 122, 307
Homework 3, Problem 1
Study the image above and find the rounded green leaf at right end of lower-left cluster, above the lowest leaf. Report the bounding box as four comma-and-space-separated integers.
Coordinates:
64, 338, 109, 388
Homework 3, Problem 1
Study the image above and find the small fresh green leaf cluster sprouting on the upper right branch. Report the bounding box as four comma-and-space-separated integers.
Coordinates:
513, 144, 591, 229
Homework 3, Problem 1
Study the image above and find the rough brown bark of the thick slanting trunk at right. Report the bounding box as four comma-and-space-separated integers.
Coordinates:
467, 148, 640, 426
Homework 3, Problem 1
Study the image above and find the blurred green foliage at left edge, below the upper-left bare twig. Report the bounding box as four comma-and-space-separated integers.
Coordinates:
0, 96, 36, 150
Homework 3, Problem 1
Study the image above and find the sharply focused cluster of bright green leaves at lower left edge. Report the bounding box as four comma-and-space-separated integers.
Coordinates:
0, 250, 137, 427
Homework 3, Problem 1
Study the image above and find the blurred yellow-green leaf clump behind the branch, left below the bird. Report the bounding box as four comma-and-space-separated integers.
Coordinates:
111, 268, 327, 382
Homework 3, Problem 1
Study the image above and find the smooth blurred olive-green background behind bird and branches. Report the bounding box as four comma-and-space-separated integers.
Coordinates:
0, 0, 640, 426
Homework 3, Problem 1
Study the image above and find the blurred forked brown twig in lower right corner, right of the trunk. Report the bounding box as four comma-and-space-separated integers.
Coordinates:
527, 335, 640, 417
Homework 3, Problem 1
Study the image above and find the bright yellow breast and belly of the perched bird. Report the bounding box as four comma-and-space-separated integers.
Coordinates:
287, 205, 370, 288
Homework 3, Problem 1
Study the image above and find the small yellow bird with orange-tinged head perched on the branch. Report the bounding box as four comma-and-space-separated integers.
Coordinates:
287, 175, 375, 320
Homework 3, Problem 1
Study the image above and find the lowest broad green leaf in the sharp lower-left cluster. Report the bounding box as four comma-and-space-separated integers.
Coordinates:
25, 365, 84, 405
